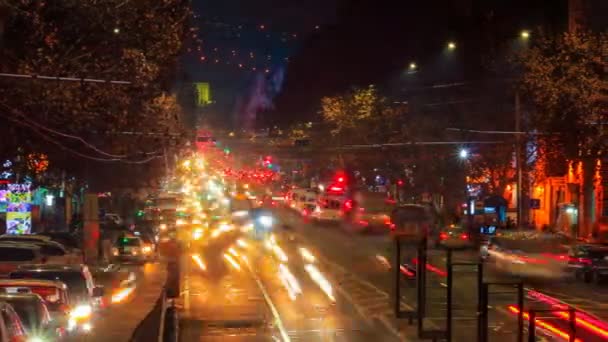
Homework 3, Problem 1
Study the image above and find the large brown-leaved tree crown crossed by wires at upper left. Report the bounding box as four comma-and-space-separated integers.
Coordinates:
0, 0, 191, 187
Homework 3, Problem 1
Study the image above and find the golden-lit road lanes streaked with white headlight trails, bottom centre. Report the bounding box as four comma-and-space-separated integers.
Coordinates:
178, 222, 394, 341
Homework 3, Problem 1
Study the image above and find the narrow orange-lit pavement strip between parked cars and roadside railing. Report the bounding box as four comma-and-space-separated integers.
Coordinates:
87, 262, 167, 342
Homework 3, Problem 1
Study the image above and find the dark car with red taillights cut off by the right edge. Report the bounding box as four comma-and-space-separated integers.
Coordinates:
568, 244, 608, 283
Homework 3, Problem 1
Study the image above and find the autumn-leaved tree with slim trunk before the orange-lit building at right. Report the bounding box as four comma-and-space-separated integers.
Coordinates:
520, 32, 608, 231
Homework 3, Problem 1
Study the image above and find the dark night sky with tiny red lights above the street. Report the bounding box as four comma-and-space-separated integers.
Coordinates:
184, 0, 565, 127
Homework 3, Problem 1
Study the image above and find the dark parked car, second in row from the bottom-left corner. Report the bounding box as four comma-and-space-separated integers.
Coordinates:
0, 293, 54, 341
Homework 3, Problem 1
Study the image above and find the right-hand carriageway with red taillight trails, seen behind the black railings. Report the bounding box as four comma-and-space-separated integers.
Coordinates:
277, 209, 608, 341
